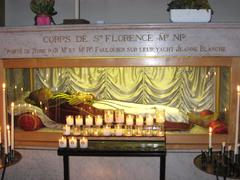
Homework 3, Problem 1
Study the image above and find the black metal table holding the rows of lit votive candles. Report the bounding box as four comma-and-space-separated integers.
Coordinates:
58, 140, 167, 180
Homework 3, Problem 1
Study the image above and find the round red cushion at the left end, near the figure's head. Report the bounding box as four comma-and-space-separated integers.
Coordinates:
17, 113, 43, 131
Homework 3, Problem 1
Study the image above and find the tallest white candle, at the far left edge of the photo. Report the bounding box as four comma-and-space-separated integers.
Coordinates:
2, 83, 8, 154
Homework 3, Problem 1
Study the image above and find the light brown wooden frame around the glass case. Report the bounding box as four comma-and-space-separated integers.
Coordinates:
0, 57, 240, 149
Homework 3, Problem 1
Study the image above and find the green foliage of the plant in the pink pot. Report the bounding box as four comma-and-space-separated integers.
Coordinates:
30, 0, 57, 16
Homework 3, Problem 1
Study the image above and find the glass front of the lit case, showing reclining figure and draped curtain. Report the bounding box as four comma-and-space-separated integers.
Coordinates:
6, 67, 230, 136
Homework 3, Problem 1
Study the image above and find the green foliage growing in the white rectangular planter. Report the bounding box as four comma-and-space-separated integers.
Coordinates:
167, 0, 211, 11
